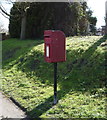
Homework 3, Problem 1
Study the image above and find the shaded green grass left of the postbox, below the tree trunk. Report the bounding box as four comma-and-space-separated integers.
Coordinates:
2, 39, 43, 69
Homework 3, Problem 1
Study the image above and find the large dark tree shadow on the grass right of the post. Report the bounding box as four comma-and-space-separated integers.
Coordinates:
59, 37, 107, 92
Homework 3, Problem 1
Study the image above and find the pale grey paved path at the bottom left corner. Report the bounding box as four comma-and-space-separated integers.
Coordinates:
0, 92, 26, 120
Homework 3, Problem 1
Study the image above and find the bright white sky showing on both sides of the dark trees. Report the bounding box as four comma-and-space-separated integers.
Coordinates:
0, 0, 107, 30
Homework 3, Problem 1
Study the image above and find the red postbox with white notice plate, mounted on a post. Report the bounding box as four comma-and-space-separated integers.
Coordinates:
44, 30, 66, 63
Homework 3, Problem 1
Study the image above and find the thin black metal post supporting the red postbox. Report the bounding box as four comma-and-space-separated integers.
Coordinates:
54, 63, 57, 104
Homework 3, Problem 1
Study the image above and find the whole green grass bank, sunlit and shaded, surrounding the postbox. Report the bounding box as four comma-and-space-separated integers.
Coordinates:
2, 36, 107, 119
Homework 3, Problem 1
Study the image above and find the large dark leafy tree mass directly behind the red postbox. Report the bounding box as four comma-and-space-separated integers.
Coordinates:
10, 2, 86, 38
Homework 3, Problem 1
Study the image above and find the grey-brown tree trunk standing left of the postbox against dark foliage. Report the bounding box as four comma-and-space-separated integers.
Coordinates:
20, 13, 26, 40
